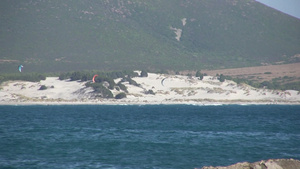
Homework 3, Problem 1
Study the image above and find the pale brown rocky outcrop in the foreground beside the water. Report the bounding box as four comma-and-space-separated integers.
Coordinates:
202, 159, 300, 169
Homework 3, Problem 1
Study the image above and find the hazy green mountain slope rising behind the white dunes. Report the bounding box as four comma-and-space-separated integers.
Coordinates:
0, 0, 300, 72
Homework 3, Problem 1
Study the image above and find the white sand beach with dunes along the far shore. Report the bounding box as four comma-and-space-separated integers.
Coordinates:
0, 73, 300, 105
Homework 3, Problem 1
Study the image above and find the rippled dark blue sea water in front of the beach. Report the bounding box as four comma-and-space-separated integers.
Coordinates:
0, 105, 300, 169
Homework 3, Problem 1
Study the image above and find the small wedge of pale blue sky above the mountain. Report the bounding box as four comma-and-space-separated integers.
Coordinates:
256, 0, 300, 19
